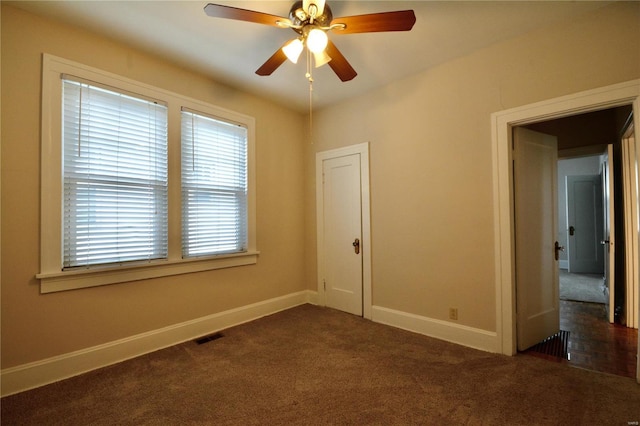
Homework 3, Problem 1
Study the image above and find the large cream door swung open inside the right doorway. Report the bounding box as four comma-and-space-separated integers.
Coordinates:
513, 127, 560, 350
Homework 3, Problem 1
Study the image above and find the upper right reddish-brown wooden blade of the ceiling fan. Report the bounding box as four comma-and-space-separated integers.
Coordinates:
331, 10, 416, 34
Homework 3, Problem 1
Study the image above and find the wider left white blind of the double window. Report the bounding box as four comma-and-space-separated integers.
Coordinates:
63, 76, 168, 268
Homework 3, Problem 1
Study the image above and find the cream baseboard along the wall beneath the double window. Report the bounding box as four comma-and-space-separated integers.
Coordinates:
0, 290, 317, 396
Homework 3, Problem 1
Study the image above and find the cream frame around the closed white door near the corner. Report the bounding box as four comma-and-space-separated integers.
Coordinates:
316, 142, 372, 319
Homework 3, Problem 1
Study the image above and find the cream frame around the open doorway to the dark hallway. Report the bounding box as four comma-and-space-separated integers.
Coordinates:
491, 80, 640, 355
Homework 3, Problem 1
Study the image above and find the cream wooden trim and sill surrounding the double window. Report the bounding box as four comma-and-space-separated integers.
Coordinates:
36, 54, 259, 293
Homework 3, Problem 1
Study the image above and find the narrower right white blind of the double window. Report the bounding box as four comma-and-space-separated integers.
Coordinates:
182, 109, 247, 257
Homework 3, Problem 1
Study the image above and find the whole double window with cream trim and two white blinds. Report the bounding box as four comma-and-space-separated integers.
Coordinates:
36, 54, 259, 293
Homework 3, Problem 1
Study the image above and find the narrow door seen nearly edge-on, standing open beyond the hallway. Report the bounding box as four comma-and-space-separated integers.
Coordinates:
602, 144, 616, 324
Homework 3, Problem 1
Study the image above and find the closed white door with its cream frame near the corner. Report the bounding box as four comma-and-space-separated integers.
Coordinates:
316, 143, 372, 319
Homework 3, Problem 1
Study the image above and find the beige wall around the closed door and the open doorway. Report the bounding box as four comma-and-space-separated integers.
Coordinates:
305, 2, 640, 331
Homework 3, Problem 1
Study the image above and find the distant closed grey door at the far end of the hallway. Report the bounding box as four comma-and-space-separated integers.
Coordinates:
567, 175, 604, 274
